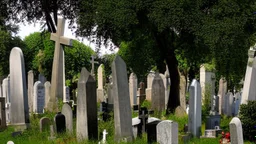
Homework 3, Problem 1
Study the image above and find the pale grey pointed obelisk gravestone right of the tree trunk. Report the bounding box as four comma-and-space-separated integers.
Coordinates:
188, 79, 202, 138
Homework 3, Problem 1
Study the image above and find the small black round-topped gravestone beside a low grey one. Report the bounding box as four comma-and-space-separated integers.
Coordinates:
54, 112, 66, 133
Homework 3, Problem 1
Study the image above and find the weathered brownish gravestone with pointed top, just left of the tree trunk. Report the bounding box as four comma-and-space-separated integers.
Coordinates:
151, 73, 165, 112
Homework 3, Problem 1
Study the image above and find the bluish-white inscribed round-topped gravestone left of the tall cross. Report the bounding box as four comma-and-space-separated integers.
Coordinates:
33, 81, 45, 114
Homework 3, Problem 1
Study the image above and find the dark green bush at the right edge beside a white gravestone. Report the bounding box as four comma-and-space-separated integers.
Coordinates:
239, 101, 256, 142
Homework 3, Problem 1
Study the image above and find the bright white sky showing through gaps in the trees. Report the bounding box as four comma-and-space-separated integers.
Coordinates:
18, 21, 118, 55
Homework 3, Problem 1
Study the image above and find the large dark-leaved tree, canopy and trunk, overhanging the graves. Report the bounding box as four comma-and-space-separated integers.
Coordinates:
6, 0, 255, 112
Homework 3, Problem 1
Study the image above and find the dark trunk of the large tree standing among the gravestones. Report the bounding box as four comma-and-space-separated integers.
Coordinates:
166, 50, 180, 114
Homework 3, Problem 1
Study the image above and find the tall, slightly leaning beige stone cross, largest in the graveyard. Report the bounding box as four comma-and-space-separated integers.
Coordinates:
47, 18, 72, 111
